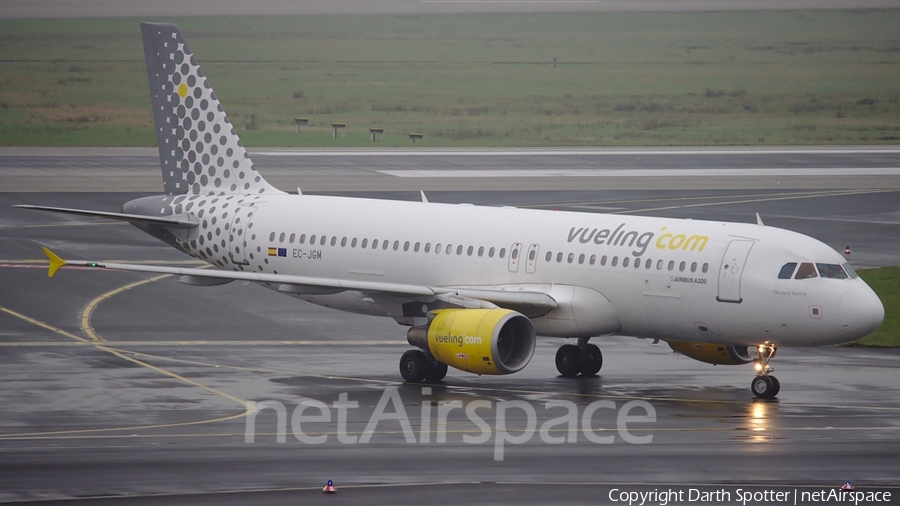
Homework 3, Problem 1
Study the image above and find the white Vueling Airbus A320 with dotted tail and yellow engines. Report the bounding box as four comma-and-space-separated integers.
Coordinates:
16, 23, 884, 399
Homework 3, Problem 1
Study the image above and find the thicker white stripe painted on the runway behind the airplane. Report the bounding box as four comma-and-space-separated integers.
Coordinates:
376, 167, 900, 178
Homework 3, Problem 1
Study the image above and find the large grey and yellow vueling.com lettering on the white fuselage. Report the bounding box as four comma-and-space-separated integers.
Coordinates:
568, 223, 709, 257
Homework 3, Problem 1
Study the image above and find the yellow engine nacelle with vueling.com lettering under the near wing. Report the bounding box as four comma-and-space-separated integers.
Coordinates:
406, 308, 537, 374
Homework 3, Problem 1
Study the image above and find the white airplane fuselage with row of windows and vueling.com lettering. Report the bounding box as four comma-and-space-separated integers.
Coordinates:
170, 195, 883, 346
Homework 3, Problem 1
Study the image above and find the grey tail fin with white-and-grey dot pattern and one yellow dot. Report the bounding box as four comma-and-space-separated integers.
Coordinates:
141, 23, 283, 195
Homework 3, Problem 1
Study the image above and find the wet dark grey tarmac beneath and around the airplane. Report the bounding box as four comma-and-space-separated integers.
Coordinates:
0, 149, 900, 505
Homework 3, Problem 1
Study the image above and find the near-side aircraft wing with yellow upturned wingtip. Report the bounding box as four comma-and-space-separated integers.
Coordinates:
42, 248, 558, 312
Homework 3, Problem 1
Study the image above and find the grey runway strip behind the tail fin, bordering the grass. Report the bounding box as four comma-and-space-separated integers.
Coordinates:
0, 146, 900, 192
